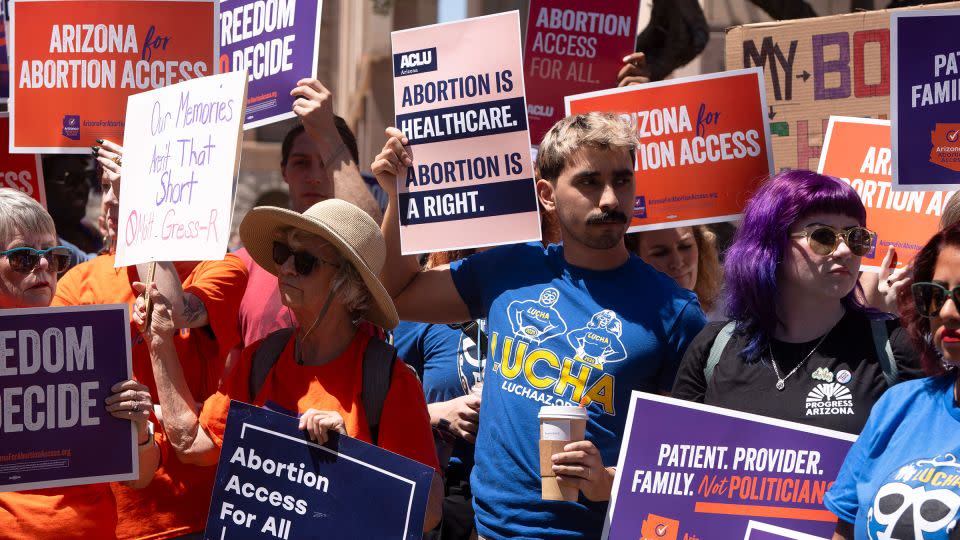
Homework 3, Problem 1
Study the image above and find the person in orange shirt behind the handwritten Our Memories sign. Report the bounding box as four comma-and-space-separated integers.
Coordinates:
53, 141, 247, 539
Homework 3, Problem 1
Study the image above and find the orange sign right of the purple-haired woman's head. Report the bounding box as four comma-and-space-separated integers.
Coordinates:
817, 116, 953, 272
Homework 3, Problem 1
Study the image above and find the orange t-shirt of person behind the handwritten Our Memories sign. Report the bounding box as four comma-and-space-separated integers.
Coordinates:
53, 254, 247, 539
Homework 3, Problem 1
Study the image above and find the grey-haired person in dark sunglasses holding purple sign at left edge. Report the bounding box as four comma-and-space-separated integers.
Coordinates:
0, 188, 160, 539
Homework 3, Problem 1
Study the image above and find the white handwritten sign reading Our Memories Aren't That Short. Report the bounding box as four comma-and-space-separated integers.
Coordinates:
116, 71, 247, 266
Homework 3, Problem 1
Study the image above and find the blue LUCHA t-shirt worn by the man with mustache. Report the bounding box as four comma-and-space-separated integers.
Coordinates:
451, 244, 705, 538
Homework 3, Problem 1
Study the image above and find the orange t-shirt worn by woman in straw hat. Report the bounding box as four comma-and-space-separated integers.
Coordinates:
200, 331, 440, 473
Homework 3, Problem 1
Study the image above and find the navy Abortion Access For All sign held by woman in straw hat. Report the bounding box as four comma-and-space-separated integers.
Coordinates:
205, 401, 433, 540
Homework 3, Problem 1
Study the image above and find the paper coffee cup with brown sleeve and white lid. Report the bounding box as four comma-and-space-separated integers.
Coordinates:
539, 405, 587, 502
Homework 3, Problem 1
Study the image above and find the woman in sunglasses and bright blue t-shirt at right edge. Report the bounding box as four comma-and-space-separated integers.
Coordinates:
824, 224, 960, 540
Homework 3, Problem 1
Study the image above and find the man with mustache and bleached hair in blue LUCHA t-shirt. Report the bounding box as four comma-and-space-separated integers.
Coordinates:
372, 113, 705, 538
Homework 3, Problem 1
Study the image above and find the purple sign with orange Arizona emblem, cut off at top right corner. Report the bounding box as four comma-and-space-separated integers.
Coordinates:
890, 9, 960, 191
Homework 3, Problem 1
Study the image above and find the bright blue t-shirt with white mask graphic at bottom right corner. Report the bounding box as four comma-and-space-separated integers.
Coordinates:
824, 375, 960, 540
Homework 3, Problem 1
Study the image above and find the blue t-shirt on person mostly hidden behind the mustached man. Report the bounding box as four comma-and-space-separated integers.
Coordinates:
393, 321, 487, 468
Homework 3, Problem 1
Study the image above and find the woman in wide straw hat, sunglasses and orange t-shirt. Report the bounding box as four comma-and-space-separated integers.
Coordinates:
134, 199, 441, 530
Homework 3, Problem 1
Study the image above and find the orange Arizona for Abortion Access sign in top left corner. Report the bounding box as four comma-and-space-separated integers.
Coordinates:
9, 0, 219, 154
